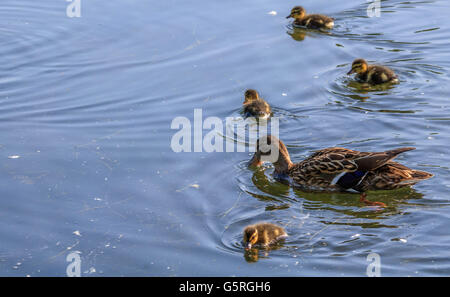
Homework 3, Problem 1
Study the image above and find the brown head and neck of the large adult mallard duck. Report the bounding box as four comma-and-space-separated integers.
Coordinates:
248, 135, 292, 173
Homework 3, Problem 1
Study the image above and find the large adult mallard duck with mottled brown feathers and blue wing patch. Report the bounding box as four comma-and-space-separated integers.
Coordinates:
249, 135, 433, 206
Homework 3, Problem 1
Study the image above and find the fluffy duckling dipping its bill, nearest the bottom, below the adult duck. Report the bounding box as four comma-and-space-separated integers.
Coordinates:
244, 222, 288, 250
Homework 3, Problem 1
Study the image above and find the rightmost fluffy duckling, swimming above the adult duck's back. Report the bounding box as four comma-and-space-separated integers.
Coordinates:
347, 59, 398, 85
